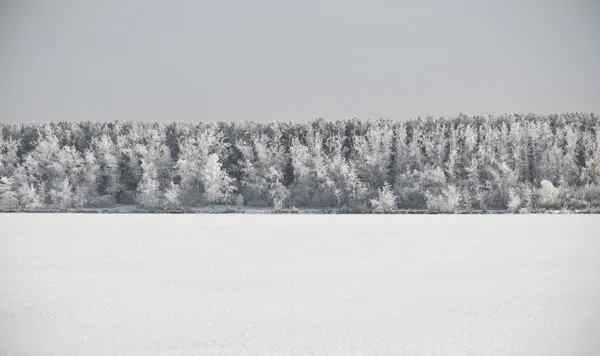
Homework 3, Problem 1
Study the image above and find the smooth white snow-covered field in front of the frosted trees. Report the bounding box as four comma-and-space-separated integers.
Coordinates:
0, 214, 600, 355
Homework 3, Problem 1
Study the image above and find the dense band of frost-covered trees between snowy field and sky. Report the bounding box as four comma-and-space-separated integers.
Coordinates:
0, 113, 600, 213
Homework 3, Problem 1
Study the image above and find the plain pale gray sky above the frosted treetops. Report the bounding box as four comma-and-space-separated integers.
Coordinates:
0, 0, 600, 122
